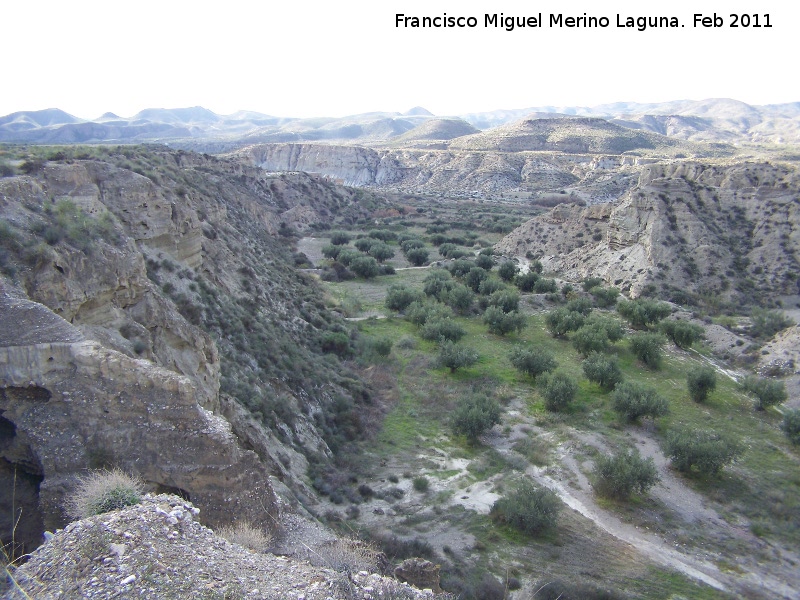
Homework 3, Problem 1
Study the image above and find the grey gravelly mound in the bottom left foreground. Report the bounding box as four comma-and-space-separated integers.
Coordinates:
4, 494, 444, 600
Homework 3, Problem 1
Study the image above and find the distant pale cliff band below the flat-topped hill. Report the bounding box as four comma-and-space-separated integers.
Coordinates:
241, 143, 650, 203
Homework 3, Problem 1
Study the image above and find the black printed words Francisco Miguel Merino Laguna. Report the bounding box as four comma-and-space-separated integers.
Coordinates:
395, 13, 681, 31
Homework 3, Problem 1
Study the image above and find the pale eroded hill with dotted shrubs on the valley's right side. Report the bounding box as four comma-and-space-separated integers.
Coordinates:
497, 161, 800, 305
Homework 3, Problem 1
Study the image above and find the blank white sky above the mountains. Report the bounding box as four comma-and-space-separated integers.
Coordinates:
0, 0, 800, 118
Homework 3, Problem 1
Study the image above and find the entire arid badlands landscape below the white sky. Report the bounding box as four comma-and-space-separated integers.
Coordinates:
0, 100, 800, 599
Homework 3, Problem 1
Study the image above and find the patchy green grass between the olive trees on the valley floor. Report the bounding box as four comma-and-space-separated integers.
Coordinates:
329, 233, 800, 599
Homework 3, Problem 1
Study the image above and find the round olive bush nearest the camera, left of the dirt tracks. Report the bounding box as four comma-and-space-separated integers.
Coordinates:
490, 478, 561, 534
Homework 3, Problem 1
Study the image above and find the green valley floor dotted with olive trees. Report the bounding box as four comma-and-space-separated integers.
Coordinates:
302, 199, 800, 598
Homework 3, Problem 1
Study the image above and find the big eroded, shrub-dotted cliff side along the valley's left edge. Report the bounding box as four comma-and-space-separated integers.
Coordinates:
0, 149, 382, 543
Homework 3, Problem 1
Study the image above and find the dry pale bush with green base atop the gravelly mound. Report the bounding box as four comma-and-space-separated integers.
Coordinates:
66, 469, 143, 519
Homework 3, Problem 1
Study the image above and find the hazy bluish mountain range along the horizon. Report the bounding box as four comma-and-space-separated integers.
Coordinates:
0, 98, 800, 152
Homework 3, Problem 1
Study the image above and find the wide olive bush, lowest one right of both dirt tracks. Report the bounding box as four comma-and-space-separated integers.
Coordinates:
666, 429, 743, 475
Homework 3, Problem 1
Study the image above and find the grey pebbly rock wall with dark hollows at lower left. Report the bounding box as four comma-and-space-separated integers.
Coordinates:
0, 290, 278, 551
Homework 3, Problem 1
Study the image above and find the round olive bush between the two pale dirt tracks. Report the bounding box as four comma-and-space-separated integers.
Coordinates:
594, 449, 659, 500
